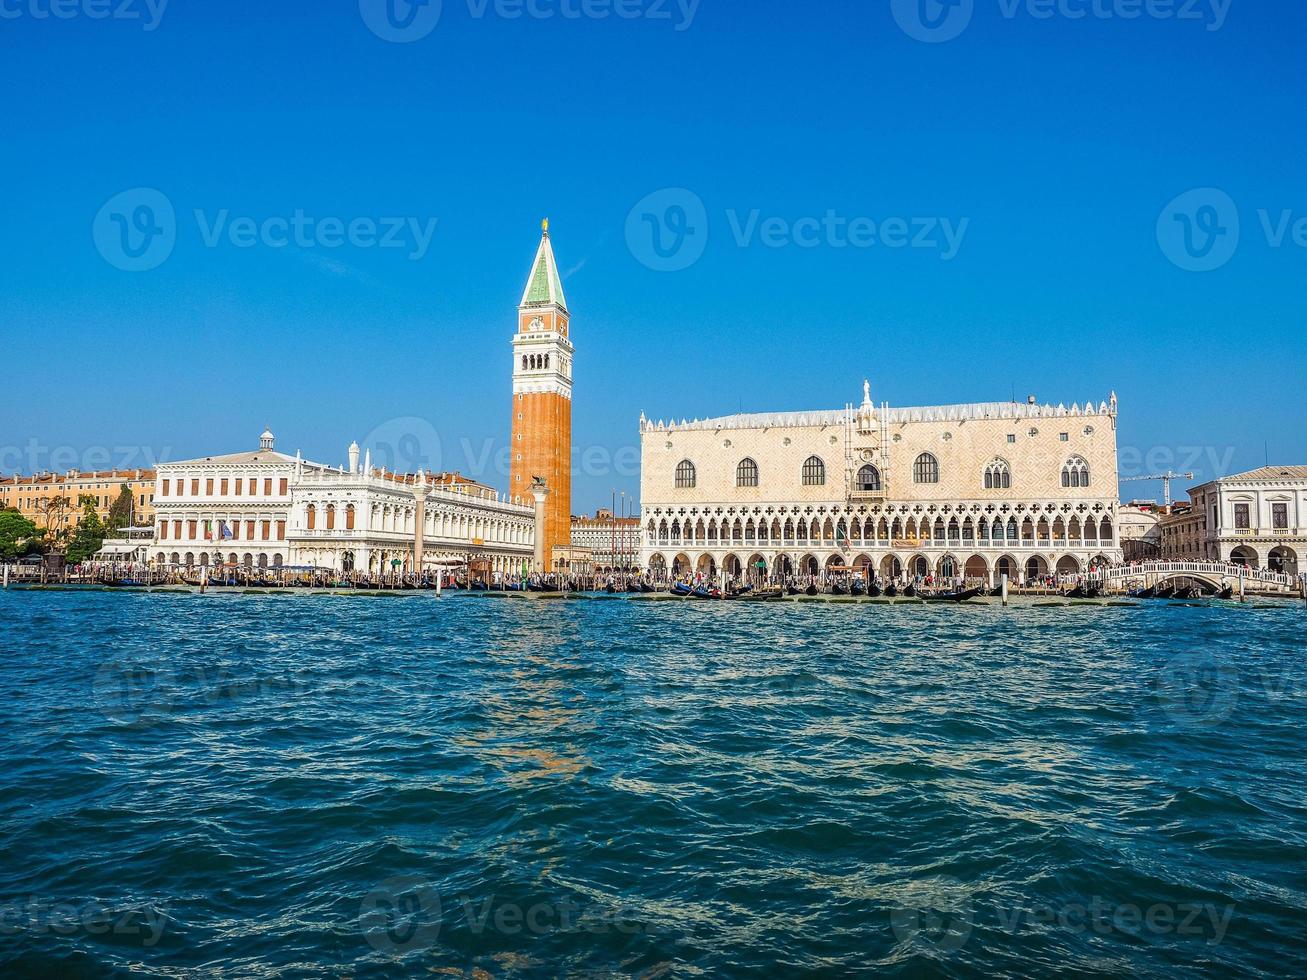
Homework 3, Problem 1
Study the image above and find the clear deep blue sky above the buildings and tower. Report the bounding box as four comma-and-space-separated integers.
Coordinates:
0, 0, 1307, 512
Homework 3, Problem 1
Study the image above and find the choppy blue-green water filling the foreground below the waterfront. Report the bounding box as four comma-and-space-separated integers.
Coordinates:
0, 592, 1307, 977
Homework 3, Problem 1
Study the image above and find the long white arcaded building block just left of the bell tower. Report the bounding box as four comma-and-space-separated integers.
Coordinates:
150, 431, 535, 575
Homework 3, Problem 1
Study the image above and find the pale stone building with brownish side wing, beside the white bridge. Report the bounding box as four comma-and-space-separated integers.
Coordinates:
1162, 466, 1307, 575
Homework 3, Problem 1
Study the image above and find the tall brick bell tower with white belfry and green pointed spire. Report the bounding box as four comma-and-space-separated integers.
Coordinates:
508, 218, 572, 571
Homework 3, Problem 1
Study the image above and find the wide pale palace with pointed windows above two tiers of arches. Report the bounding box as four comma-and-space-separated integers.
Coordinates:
640, 384, 1121, 583
